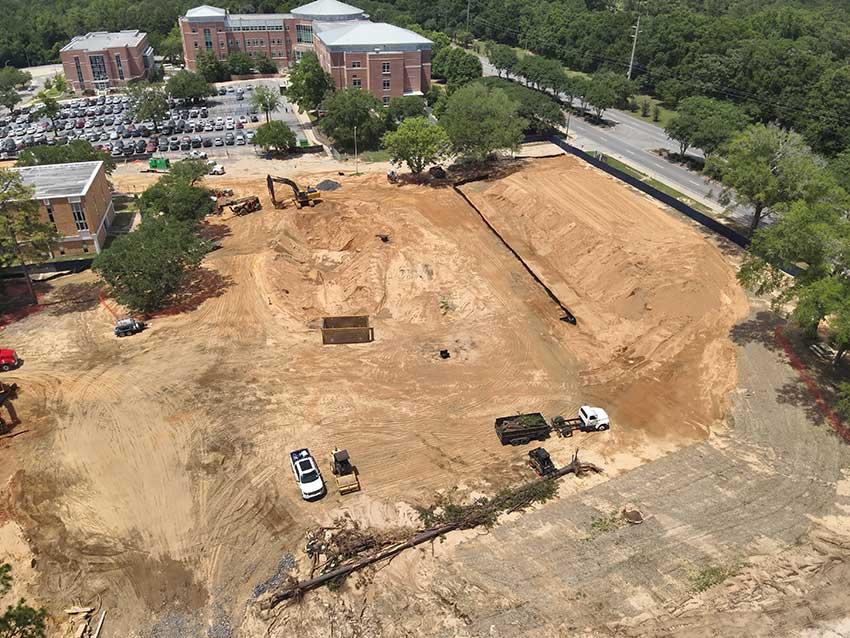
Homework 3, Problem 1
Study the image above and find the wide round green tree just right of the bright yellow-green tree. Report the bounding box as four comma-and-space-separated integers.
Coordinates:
440, 83, 526, 161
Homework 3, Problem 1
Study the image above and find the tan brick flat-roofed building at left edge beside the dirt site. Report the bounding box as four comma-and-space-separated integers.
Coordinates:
11, 162, 115, 255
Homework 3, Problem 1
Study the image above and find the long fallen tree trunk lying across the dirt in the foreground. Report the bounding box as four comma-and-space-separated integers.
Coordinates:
260, 450, 603, 610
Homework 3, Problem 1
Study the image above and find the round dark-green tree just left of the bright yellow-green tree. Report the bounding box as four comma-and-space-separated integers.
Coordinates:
319, 87, 384, 151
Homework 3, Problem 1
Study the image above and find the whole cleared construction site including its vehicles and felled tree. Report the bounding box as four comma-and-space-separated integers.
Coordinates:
0, 145, 850, 638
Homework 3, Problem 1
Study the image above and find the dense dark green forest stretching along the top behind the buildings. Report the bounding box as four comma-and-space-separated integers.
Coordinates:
0, 0, 850, 155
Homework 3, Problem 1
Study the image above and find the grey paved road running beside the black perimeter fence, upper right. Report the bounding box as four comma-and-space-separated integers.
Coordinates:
478, 55, 746, 228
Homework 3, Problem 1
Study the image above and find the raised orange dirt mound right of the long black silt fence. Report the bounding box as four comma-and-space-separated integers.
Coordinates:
464, 157, 747, 440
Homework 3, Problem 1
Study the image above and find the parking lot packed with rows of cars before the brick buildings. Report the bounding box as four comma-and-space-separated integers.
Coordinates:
0, 79, 305, 158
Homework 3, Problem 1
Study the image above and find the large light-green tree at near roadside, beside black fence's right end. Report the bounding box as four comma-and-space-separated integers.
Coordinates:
708, 124, 828, 235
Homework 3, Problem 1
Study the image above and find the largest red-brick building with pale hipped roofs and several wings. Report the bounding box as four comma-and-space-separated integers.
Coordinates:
180, 0, 431, 103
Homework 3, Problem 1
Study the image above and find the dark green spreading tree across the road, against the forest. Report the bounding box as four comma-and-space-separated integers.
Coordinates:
664, 97, 749, 157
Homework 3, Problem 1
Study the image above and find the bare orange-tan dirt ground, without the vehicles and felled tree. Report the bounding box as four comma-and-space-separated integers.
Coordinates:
0, 151, 843, 638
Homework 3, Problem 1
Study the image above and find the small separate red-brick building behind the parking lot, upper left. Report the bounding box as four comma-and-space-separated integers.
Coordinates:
59, 30, 154, 91
